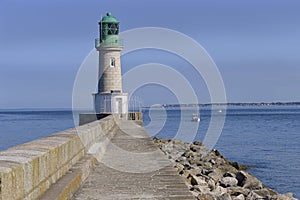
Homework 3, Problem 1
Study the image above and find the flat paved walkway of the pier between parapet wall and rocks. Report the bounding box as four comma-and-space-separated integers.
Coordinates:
73, 121, 195, 200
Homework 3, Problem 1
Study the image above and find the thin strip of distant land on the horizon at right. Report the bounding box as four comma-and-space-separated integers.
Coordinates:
143, 102, 300, 108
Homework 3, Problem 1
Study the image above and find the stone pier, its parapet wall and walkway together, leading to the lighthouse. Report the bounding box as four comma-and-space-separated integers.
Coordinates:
0, 116, 194, 200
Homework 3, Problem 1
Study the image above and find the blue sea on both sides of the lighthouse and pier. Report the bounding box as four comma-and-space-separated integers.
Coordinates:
0, 106, 300, 198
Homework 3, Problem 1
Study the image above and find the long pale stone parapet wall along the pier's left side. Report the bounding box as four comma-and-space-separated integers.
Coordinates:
0, 116, 115, 200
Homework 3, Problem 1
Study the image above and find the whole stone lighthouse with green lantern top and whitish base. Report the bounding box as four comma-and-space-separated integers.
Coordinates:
94, 13, 128, 117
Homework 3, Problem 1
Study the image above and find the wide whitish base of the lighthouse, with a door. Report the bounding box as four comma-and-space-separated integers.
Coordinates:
94, 93, 128, 117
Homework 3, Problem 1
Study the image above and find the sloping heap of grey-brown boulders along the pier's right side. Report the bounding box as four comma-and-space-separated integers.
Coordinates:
153, 138, 296, 200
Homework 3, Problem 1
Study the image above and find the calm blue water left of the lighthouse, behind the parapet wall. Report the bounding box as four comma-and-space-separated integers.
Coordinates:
0, 110, 74, 150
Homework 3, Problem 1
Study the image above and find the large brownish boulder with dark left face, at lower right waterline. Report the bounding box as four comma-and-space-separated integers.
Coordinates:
236, 171, 262, 190
